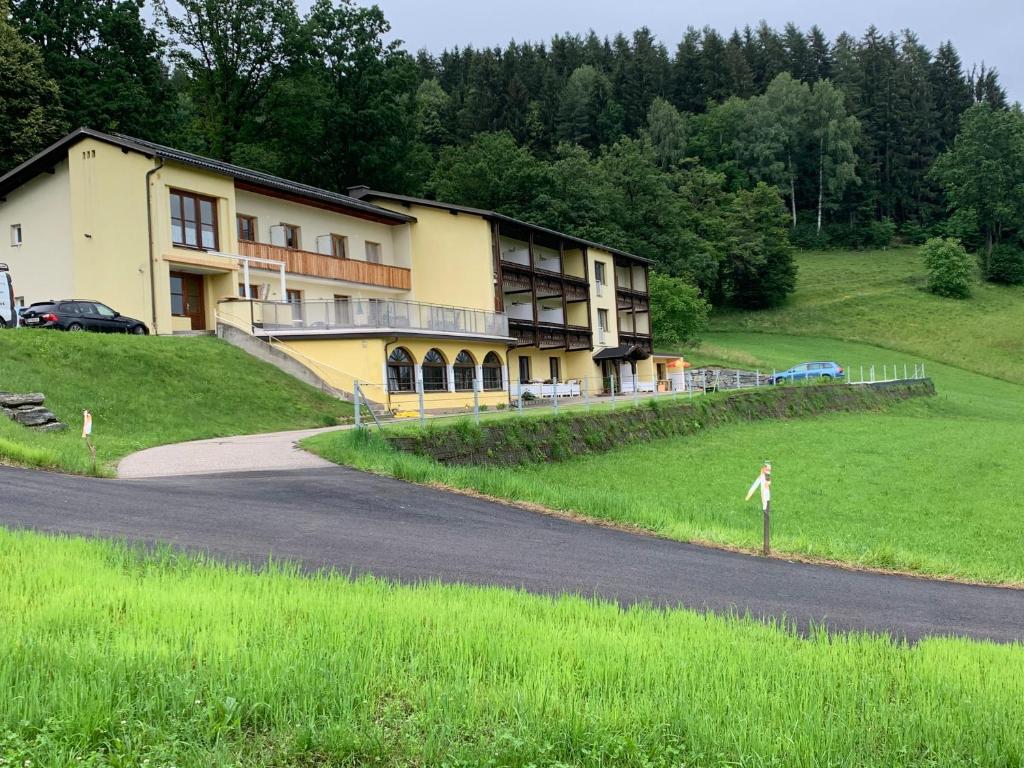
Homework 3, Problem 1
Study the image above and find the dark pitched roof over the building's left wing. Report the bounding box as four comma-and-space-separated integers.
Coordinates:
0, 128, 416, 224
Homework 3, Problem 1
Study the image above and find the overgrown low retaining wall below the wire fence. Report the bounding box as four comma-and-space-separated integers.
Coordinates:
388, 379, 935, 466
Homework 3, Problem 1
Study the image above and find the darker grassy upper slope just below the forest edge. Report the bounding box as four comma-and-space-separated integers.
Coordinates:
706, 248, 1024, 384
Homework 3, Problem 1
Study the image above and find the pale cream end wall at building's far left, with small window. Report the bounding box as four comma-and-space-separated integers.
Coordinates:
0, 162, 74, 304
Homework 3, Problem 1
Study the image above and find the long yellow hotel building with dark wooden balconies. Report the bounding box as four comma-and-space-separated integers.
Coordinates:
0, 129, 655, 411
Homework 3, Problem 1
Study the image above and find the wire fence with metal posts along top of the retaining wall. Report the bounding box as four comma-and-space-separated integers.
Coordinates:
352, 361, 926, 428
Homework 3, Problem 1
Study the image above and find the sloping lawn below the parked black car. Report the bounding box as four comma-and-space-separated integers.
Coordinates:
0, 331, 351, 473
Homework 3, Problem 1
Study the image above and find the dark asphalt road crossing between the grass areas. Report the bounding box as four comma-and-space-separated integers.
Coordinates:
0, 467, 1024, 641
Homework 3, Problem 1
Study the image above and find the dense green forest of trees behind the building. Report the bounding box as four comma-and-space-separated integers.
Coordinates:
0, 0, 1024, 323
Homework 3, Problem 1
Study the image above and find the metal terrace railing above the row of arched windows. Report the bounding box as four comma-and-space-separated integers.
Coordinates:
252, 299, 509, 338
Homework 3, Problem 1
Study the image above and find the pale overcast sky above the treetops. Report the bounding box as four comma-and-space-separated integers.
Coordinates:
362, 0, 1024, 101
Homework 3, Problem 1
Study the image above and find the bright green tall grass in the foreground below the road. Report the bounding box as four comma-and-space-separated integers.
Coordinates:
0, 530, 1024, 768
